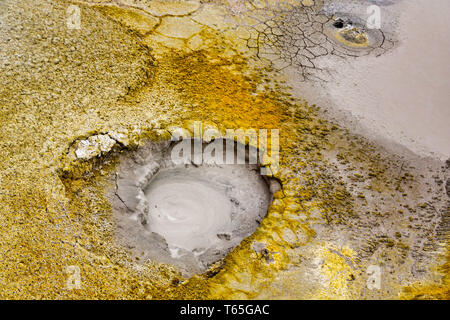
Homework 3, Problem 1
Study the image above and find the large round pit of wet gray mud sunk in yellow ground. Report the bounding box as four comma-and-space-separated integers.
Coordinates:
112, 142, 281, 276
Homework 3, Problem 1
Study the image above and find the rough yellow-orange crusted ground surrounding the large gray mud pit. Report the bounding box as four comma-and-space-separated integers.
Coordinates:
0, 0, 450, 299
